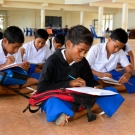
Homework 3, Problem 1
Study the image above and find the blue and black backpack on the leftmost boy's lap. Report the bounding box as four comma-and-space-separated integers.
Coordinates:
0, 67, 28, 86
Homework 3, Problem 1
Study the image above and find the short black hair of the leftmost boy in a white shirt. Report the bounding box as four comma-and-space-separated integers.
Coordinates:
3, 26, 24, 44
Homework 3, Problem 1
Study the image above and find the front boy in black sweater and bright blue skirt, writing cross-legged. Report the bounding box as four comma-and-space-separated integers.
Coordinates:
37, 25, 124, 125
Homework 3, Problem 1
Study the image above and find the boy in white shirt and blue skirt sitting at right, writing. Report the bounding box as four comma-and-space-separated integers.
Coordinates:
86, 28, 135, 93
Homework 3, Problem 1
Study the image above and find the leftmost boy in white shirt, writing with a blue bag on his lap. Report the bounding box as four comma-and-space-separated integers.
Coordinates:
0, 26, 38, 92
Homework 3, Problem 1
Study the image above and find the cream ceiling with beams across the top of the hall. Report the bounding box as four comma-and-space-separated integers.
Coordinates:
0, 0, 135, 11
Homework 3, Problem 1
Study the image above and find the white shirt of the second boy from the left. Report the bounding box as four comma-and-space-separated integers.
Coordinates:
22, 40, 51, 64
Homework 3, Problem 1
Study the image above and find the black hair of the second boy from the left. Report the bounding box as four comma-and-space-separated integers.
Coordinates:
35, 29, 49, 40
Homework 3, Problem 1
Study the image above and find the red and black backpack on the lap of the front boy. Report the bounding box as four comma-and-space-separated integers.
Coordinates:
23, 88, 97, 122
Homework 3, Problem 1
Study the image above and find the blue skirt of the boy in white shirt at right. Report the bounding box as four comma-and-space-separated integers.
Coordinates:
94, 70, 135, 94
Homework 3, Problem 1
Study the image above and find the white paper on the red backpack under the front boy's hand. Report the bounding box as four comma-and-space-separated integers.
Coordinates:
66, 87, 118, 96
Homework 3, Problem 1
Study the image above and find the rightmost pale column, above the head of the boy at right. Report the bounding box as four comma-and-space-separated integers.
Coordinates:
122, 3, 128, 31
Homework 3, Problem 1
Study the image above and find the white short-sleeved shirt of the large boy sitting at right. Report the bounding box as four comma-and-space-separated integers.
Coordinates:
86, 43, 130, 72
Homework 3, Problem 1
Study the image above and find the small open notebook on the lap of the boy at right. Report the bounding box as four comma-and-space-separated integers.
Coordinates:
98, 77, 121, 85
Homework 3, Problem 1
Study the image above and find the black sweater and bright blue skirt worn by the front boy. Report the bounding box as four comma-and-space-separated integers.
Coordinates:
37, 49, 124, 122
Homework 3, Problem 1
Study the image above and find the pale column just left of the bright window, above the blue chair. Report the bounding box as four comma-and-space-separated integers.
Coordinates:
97, 7, 103, 36
